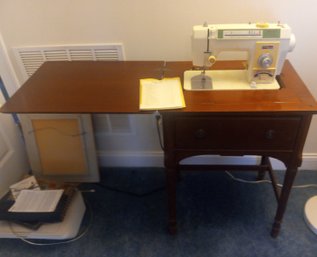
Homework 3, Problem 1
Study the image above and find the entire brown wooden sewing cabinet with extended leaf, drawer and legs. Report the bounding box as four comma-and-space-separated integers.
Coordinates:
1, 61, 317, 237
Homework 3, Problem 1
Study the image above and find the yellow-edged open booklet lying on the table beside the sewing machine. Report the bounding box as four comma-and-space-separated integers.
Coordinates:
140, 78, 185, 110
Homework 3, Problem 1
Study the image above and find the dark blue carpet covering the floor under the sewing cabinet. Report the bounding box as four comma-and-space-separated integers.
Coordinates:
0, 168, 317, 257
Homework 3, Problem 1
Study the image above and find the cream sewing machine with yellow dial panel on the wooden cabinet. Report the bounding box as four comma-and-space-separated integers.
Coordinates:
184, 23, 295, 90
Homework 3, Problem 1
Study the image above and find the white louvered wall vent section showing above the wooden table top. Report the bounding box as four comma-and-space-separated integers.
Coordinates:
14, 44, 124, 79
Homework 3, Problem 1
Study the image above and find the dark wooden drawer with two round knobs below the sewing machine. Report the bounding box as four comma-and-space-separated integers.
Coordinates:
174, 116, 301, 151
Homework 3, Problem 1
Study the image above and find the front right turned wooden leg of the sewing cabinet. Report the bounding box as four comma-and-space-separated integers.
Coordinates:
271, 168, 297, 238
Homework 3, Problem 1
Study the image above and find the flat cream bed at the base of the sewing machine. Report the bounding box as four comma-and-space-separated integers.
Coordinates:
184, 70, 280, 91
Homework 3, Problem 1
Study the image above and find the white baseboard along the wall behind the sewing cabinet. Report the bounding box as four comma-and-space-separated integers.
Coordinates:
98, 151, 317, 170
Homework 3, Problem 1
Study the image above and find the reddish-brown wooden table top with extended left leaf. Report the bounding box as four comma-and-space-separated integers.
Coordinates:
0, 61, 317, 113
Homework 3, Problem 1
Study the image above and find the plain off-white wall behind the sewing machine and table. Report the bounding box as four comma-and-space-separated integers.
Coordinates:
0, 0, 317, 169
